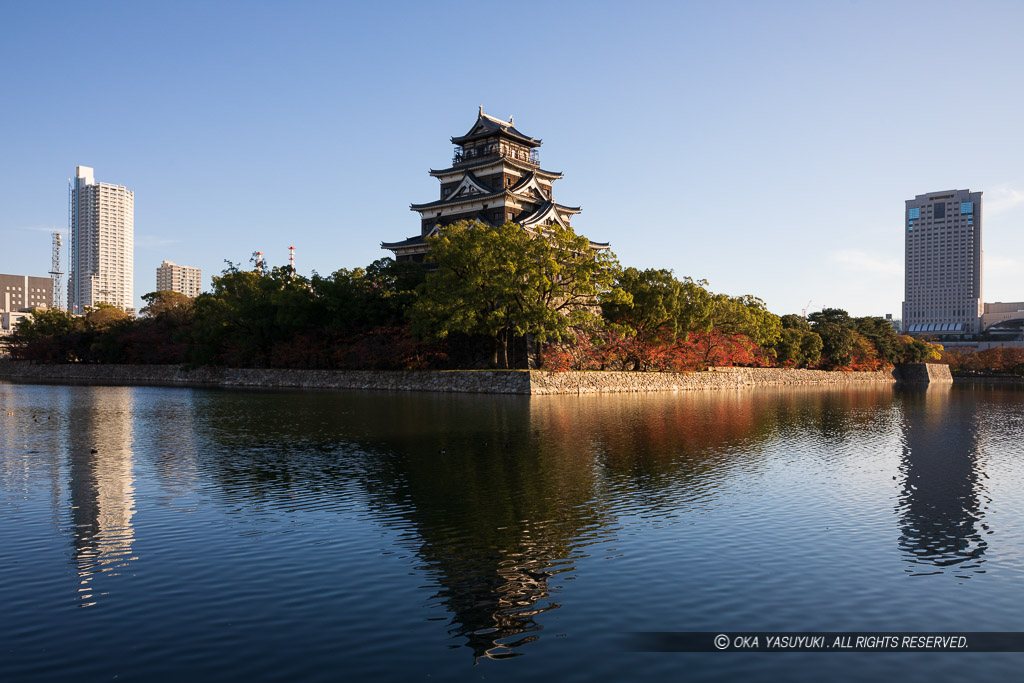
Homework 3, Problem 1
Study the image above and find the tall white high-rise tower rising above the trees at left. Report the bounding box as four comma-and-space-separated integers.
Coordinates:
68, 166, 135, 313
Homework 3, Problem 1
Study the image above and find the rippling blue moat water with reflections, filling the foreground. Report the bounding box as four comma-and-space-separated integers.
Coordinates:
0, 383, 1024, 681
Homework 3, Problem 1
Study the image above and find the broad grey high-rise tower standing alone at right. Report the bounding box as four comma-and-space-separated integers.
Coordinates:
903, 189, 984, 335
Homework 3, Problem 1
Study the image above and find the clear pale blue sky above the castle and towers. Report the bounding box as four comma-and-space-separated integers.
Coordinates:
0, 0, 1024, 315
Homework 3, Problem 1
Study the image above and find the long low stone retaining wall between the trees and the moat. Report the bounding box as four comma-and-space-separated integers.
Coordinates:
0, 360, 913, 394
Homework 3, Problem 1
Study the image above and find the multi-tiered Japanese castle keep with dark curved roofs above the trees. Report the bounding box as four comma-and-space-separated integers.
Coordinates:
381, 106, 608, 262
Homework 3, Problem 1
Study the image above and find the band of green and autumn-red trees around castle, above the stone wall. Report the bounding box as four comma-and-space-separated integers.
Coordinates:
3, 221, 958, 372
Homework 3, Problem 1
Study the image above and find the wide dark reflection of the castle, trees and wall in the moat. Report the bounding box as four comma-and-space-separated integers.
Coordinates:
180, 387, 909, 658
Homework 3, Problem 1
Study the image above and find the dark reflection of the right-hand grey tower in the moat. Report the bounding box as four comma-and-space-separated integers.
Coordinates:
896, 385, 988, 579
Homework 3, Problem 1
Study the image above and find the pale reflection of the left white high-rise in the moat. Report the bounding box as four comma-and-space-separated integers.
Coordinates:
68, 387, 136, 607
